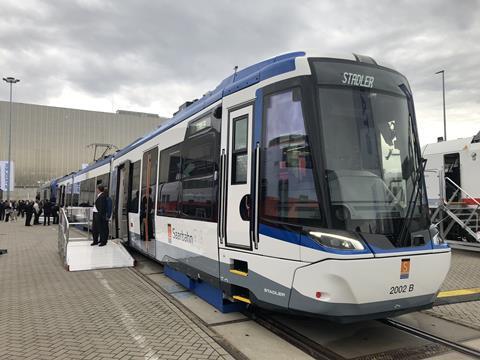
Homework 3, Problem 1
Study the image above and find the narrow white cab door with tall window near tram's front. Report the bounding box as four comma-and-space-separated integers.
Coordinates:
223, 106, 253, 249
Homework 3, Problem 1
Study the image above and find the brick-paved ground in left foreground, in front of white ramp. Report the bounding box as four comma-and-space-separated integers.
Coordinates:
0, 222, 232, 360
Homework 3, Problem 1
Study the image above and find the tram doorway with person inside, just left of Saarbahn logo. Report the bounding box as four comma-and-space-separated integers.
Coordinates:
140, 148, 158, 240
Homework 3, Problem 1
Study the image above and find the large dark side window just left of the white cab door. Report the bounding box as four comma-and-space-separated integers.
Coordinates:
181, 133, 218, 221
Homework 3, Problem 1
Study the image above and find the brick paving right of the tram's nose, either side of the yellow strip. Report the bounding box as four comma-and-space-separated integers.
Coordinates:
426, 250, 480, 330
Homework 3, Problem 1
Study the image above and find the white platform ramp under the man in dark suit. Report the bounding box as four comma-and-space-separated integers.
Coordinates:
65, 240, 135, 271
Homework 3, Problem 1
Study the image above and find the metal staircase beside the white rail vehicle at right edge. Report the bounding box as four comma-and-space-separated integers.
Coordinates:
432, 171, 480, 251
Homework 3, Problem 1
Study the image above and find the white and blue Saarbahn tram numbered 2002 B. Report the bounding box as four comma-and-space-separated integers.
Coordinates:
53, 52, 450, 321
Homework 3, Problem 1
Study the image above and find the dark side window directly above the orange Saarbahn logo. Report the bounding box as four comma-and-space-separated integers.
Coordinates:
157, 144, 182, 216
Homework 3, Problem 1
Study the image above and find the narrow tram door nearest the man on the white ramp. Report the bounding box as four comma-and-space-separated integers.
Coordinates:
115, 161, 132, 242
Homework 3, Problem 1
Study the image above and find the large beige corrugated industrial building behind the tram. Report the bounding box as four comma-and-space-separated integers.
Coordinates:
0, 101, 165, 199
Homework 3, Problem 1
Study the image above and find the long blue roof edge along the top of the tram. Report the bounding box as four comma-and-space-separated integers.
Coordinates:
113, 51, 305, 158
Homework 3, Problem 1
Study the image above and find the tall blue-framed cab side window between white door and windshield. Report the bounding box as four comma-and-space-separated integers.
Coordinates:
260, 89, 322, 225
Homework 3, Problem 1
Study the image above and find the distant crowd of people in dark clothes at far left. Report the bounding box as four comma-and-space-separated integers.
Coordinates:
0, 197, 59, 226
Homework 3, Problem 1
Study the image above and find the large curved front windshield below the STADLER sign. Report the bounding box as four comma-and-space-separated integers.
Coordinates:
319, 86, 428, 240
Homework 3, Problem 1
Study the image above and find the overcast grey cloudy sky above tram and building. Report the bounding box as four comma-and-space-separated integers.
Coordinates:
0, 0, 480, 143
